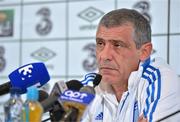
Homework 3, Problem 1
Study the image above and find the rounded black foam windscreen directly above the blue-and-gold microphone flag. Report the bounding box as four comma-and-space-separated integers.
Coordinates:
66, 80, 83, 91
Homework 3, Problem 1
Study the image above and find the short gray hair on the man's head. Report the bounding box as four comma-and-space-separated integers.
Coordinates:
99, 9, 151, 48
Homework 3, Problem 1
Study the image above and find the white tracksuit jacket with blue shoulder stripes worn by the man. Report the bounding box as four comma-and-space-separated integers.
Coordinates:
82, 58, 180, 122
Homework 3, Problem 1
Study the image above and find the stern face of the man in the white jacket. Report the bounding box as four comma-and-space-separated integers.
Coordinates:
96, 25, 140, 85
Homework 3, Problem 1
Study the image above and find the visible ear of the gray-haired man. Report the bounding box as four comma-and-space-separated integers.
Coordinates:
140, 42, 152, 61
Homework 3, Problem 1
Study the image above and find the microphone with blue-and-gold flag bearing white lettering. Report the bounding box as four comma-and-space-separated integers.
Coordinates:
59, 87, 95, 122
